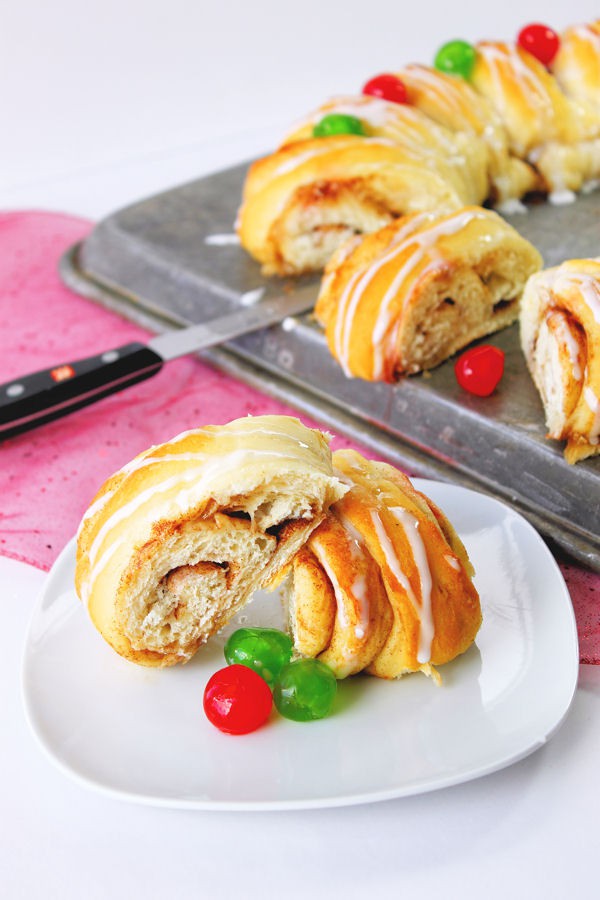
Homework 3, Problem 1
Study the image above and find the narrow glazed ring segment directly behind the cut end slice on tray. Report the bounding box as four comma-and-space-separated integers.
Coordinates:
282, 94, 490, 203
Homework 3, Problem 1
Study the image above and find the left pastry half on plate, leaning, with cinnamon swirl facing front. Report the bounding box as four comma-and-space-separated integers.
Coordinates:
76, 416, 347, 666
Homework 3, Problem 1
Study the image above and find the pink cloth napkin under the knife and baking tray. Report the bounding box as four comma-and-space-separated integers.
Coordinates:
0, 212, 600, 663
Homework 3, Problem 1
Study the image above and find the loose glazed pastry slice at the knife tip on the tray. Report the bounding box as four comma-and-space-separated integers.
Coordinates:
315, 206, 542, 382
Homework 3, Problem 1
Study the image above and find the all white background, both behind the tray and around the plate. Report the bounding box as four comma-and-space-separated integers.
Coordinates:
0, 0, 600, 900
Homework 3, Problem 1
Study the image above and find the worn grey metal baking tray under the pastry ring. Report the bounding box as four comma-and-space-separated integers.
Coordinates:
61, 164, 600, 571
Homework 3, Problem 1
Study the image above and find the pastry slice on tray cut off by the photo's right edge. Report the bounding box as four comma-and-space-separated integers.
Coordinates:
521, 259, 600, 463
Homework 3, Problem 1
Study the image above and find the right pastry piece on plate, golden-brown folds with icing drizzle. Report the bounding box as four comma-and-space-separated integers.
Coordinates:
289, 450, 481, 680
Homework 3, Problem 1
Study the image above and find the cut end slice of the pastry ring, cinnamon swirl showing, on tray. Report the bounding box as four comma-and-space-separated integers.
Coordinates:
237, 135, 469, 275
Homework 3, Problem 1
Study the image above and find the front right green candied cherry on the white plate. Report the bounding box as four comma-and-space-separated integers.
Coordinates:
273, 659, 337, 722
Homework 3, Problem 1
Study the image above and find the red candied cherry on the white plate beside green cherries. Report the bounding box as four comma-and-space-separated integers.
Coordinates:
204, 665, 273, 734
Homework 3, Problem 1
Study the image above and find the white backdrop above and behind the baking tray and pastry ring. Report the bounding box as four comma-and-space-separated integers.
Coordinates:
0, 0, 600, 216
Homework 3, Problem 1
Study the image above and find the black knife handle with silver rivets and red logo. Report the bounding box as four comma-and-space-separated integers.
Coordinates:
0, 343, 163, 440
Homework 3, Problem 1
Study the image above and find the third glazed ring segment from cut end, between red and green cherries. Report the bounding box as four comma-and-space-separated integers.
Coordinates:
398, 64, 542, 211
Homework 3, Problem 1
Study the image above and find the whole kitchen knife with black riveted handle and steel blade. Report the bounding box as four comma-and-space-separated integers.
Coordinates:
0, 293, 314, 440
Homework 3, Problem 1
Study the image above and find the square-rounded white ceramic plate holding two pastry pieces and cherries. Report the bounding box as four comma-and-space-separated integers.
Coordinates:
23, 479, 578, 809
